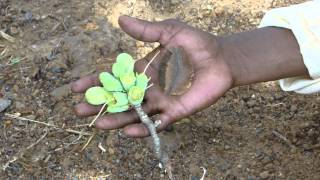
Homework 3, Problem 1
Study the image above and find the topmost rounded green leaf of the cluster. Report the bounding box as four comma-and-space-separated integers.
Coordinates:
112, 53, 134, 78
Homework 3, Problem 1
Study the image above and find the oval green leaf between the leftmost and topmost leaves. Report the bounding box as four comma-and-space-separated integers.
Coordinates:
99, 72, 123, 91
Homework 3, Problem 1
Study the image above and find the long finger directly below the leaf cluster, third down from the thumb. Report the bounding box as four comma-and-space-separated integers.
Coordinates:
96, 104, 158, 130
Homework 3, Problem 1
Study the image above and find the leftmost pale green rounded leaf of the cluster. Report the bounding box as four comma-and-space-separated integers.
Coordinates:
85, 86, 114, 105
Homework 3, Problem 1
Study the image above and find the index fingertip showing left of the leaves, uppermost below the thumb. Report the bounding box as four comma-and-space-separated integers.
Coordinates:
71, 74, 100, 93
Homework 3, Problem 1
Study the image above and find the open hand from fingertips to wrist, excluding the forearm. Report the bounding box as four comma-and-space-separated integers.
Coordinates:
72, 16, 233, 137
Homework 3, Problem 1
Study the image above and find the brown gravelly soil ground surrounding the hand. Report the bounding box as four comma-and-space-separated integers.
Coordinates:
0, 0, 320, 180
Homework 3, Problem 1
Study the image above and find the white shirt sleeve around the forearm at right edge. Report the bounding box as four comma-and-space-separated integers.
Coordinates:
259, 0, 320, 94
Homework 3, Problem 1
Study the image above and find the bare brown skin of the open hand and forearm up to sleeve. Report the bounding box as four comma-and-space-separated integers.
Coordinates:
72, 16, 308, 137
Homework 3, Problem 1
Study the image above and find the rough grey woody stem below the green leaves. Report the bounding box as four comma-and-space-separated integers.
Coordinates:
134, 104, 163, 160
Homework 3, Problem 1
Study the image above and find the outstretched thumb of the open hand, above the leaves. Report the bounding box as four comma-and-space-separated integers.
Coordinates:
119, 16, 183, 45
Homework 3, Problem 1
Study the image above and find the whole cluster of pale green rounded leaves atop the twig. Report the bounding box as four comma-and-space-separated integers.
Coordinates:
85, 53, 150, 113
